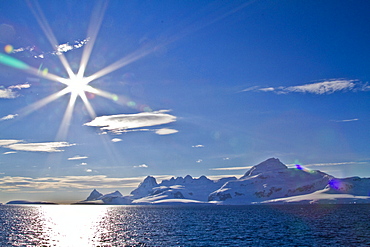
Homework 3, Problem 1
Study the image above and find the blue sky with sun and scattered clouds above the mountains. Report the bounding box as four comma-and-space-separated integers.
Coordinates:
0, 0, 370, 202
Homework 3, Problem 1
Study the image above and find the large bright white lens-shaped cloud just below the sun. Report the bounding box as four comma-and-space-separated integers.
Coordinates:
84, 110, 176, 133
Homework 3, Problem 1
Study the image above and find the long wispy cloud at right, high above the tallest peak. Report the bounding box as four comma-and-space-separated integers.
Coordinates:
242, 79, 370, 94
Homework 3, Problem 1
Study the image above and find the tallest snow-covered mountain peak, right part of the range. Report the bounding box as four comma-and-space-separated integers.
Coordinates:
208, 158, 333, 204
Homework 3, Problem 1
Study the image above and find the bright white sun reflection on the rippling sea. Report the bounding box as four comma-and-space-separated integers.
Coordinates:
39, 205, 108, 247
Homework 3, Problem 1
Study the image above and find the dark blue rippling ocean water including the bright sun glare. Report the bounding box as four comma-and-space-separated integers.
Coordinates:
0, 205, 370, 247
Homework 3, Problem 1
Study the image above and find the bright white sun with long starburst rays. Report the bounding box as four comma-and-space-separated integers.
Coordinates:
0, 1, 158, 140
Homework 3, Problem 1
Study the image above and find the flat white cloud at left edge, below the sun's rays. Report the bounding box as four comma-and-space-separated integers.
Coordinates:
0, 140, 75, 153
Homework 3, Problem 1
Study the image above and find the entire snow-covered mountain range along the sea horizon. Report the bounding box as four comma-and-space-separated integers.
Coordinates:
79, 158, 370, 205
